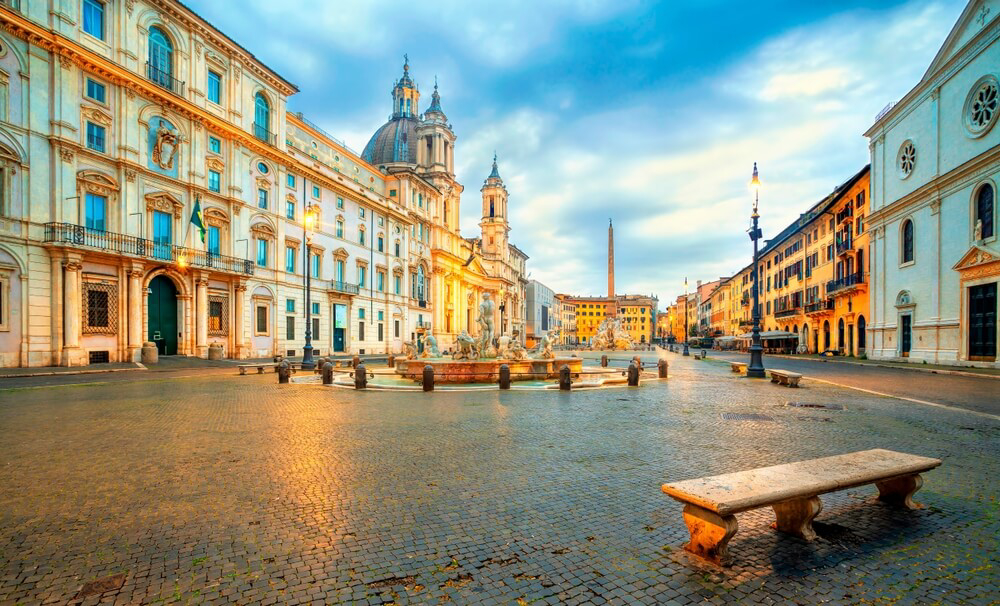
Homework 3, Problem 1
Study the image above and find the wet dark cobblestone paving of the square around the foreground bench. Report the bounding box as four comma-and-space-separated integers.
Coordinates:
0, 357, 1000, 604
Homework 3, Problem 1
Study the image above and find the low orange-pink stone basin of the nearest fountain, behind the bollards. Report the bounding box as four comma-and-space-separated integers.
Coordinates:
396, 358, 583, 383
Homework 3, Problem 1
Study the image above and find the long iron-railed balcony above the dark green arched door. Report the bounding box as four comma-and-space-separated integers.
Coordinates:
45, 223, 254, 276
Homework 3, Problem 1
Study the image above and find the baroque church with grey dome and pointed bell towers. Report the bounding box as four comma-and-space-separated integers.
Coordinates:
362, 61, 528, 348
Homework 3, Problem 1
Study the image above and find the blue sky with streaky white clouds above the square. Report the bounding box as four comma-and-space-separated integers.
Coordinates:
188, 0, 965, 308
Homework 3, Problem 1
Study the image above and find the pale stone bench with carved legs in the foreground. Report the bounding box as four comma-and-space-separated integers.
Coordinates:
662, 449, 941, 566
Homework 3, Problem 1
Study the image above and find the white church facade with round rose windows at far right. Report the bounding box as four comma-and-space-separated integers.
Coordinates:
866, 0, 1000, 366
